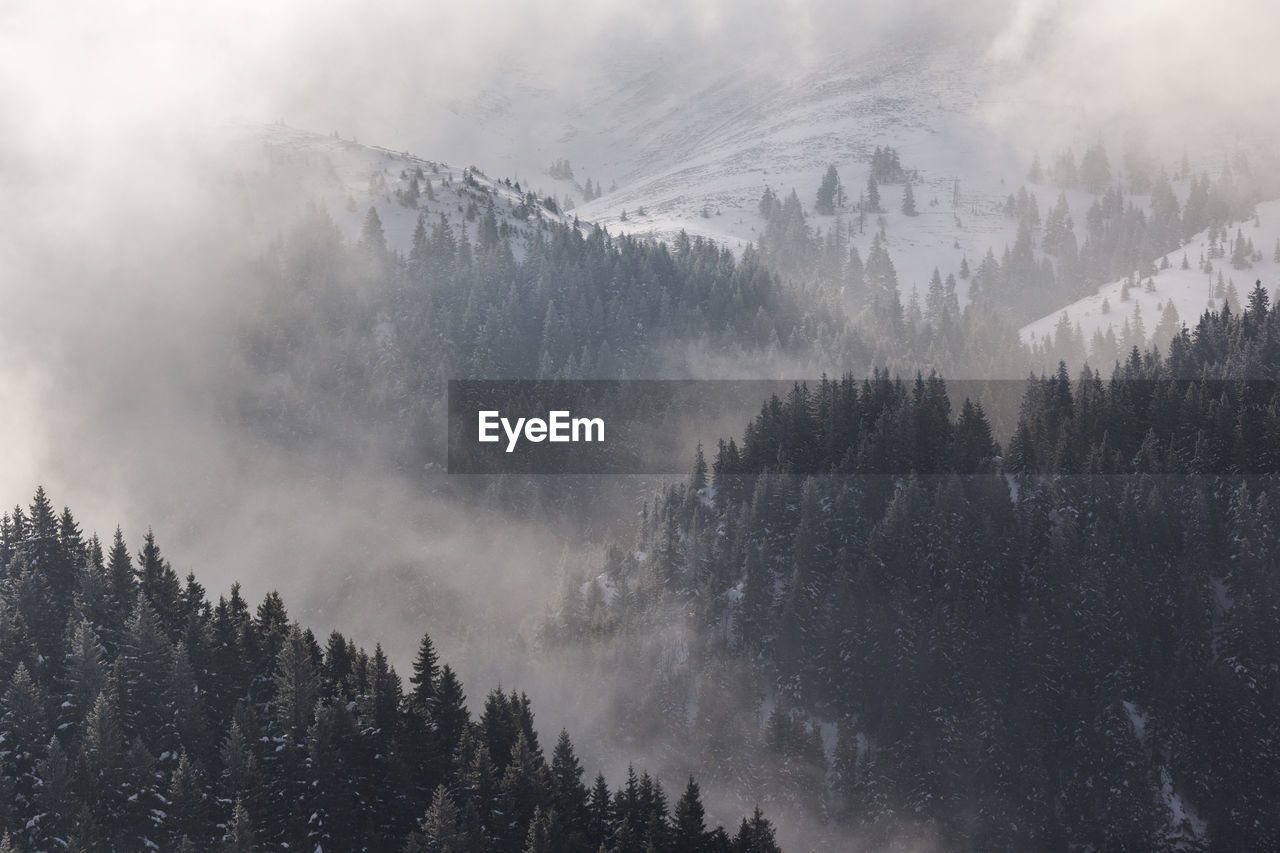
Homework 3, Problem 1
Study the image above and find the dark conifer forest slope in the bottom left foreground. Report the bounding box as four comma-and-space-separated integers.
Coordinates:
0, 489, 780, 853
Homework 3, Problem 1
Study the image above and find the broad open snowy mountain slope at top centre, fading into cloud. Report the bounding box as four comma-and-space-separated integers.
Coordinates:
440, 40, 1029, 301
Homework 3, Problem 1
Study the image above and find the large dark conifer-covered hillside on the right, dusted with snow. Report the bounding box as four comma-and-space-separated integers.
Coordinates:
543, 286, 1280, 850
